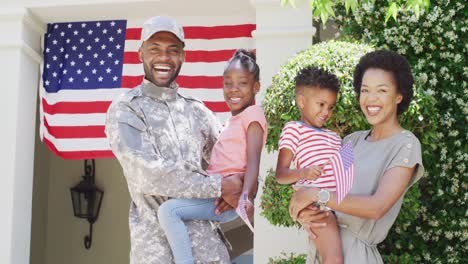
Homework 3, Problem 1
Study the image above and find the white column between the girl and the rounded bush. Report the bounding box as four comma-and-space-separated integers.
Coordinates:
251, 0, 315, 263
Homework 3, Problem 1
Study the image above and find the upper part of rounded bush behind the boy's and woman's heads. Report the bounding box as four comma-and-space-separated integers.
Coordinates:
263, 41, 373, 151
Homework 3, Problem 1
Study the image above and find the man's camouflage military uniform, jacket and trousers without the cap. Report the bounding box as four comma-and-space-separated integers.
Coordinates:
106, 80, 229, 264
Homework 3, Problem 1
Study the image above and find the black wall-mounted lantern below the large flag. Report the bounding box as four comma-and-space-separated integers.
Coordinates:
70, 159, 104, 249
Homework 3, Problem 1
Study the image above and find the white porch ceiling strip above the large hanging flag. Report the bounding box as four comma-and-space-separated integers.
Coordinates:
16, 0, 255, 23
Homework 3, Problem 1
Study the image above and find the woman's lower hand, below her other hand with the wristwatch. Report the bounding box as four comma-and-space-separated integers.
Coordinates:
297, 205, 330, 240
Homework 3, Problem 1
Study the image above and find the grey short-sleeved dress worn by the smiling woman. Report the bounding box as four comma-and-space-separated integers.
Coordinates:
308, 130, 424, 264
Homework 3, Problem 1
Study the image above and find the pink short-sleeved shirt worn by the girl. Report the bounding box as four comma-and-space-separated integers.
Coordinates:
208, 105, 267, 176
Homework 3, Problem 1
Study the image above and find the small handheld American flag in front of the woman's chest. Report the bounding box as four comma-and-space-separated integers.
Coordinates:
330, 143, 354, 204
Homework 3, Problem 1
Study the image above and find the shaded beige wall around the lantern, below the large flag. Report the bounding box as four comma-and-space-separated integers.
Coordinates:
30, 101, 130, 264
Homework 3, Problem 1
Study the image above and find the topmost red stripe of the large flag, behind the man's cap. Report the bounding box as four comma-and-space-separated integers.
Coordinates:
125, 24, 256, 40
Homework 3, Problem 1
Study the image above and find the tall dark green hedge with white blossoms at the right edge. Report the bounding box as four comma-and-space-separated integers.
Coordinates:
337, 0, 468, 263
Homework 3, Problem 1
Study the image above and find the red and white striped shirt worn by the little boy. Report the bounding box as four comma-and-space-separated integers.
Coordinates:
279, 121, 341, 191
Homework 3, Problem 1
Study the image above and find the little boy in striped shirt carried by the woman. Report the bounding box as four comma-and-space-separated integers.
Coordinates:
276, 67, 343, 264
